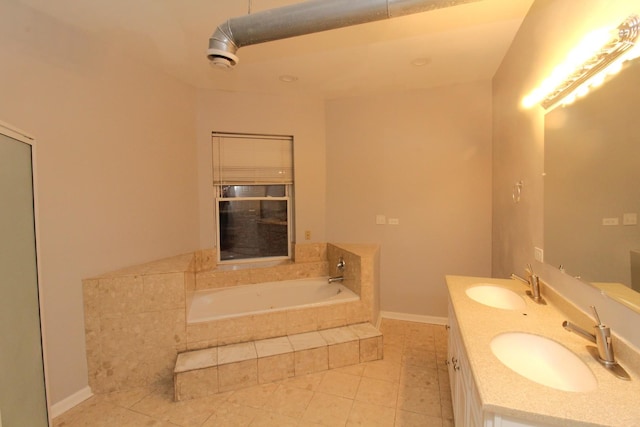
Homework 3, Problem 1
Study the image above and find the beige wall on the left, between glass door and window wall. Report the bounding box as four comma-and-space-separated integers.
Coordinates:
0, 2, 198, 403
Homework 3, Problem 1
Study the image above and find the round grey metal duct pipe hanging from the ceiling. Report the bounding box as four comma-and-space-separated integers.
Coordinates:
207, 0, 478, 68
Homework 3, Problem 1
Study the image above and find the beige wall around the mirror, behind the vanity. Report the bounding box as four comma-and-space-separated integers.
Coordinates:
492, 0, 640, 346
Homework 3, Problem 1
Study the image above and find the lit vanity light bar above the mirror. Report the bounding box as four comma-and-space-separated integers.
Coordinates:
522, 15, 640, 109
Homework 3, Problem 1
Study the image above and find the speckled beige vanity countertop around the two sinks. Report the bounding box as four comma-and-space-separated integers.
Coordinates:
446, 276, 640, 426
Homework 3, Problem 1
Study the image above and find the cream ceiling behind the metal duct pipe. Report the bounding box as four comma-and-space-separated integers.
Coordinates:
18, 0, 533, 98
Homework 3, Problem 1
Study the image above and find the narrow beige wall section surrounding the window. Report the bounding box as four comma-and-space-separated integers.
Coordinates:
197, 90, 326, 249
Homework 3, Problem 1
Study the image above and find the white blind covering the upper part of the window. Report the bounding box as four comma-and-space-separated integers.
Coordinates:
212, 133, 293, 185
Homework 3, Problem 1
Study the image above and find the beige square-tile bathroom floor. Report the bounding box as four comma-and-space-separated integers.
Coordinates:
53, 319, 453, 427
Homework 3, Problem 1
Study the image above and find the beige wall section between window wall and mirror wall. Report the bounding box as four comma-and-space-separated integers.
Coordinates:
326, 82, 491, 317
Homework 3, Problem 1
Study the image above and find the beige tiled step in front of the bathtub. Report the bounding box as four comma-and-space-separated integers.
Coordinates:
173, 323, 382, 401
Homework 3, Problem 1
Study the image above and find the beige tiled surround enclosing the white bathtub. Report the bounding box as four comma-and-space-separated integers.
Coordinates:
83, 244, 379, 393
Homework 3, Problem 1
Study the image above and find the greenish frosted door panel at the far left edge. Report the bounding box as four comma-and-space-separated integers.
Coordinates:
0, 130, 48, 427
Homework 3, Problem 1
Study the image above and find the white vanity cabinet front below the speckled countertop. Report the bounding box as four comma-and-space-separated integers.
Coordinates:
447, 304, 483, 427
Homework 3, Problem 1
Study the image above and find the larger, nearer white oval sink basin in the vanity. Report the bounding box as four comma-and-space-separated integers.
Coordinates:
491, 332, 598, 391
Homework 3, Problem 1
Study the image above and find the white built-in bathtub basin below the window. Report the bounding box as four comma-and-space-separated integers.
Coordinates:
187, 277, 360, 323
